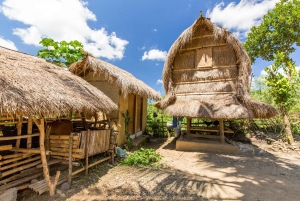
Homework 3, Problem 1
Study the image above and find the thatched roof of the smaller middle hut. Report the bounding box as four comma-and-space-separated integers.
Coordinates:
69, 55, 161, 100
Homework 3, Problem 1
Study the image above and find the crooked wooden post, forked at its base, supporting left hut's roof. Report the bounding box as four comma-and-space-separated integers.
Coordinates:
33, 118, 60, 197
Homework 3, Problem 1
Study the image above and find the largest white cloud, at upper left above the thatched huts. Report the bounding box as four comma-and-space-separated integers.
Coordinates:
0, 0, 128, 59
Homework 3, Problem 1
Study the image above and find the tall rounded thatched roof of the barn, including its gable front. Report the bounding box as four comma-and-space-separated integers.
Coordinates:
155, 16, 278, 119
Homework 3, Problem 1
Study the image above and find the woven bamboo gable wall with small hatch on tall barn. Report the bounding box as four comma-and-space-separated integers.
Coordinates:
172, 26, 238, 94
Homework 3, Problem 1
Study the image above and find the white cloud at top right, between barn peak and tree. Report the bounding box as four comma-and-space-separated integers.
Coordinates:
206, 0, 280, 38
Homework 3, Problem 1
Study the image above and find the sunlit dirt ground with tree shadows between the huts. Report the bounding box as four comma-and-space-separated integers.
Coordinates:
22, 133, 300, 201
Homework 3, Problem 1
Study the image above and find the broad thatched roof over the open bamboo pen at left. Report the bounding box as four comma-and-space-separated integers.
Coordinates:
0, 47, 117, 115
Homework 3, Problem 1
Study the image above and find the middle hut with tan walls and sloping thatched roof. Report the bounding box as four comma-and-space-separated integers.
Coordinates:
69, 55, 161, 144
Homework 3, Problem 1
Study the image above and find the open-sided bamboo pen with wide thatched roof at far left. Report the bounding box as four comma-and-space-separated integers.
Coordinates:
0, 47, 117, 200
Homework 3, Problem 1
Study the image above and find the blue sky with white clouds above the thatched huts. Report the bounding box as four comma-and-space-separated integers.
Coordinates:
0, 0, 300, 92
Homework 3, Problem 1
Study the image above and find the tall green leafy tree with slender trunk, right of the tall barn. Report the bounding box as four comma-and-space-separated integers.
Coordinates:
244, 0, 300, 143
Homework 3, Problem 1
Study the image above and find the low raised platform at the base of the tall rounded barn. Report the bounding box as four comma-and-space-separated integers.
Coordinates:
176, 137, 239, 154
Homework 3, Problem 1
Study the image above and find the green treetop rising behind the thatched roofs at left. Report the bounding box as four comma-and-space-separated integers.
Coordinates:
37, 38, 86, 67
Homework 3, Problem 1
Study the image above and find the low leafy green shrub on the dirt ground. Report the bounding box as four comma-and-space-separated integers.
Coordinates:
121, 148, 161, 166
